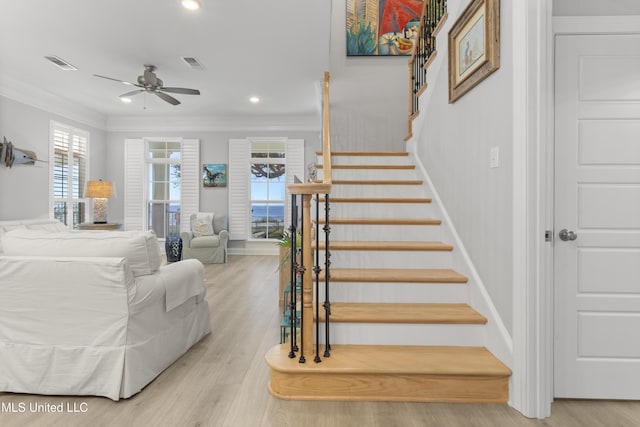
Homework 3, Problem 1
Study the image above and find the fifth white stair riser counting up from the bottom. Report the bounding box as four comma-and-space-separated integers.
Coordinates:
320, 201, 433, 222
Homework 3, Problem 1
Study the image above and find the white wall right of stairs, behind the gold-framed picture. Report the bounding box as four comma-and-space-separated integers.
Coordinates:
414, 0, 513, 333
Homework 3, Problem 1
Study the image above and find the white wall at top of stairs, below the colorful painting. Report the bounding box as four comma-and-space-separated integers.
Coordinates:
330, 0, 409, 151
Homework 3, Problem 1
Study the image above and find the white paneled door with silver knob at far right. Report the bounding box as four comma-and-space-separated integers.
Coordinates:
554, 35, 640, 399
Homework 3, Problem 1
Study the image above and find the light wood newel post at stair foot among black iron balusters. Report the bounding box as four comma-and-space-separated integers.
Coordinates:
302, 194, 315, 357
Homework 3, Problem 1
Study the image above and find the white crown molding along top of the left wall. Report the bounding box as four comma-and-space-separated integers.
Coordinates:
0, 76, 107, 130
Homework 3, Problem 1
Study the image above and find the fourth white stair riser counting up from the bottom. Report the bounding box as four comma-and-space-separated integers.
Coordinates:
320, 224, 442, 242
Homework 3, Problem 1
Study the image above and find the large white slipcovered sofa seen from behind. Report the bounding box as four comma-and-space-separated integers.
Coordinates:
0, 227, 211, 400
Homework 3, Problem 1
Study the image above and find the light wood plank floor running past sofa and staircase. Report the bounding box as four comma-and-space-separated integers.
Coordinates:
0, 256, 640, 427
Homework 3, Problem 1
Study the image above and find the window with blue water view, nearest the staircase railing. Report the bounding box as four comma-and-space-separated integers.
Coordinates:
250, 141, 286, 239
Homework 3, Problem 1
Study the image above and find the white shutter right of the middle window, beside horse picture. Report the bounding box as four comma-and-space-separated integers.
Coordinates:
180, 139, 201, 231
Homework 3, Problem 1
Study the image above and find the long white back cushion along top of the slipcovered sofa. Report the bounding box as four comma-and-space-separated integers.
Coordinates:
2, 230, 162, 276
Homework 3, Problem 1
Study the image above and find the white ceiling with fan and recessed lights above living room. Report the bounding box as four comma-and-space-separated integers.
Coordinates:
0, 0, 331, 117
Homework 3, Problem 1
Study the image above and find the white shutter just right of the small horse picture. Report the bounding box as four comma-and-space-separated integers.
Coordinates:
227, 139, 251, 240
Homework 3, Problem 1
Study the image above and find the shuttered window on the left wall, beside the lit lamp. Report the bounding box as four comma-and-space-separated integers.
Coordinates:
49, 122, 89, 229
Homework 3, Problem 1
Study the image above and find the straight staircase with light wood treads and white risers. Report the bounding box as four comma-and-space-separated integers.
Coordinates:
266, 152, 511, 402
